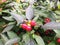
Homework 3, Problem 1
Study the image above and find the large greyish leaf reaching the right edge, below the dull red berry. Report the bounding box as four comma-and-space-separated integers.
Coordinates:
42, 22, 60, 30
